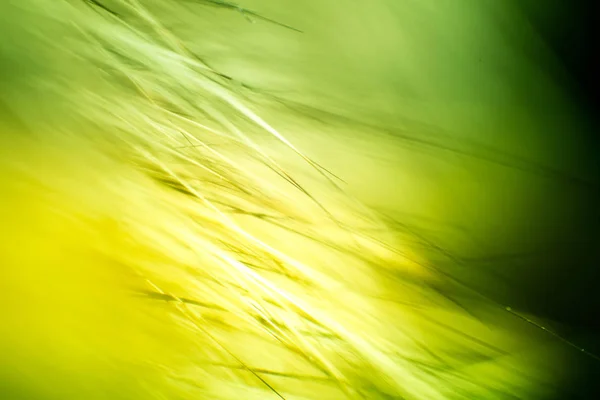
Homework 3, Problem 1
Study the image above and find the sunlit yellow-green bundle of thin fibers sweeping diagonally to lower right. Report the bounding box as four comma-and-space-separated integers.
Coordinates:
0, 0, 592, 400
